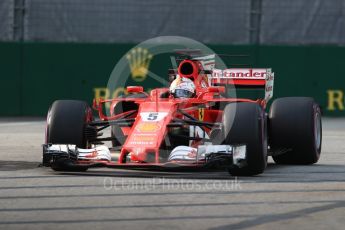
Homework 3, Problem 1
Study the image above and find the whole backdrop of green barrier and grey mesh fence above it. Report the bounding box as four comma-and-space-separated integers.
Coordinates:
0, 0, 345, 116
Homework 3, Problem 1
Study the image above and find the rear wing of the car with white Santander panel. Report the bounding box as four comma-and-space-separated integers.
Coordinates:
209, 68, 274, 102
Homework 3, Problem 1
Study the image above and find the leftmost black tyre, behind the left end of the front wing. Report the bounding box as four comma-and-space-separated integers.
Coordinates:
46, 100, 92, 148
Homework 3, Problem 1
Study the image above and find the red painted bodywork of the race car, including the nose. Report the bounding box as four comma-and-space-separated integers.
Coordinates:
86, 60, 266, 167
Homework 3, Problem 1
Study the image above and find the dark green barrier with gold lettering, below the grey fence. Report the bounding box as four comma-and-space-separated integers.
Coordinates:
0, 43, 345, 116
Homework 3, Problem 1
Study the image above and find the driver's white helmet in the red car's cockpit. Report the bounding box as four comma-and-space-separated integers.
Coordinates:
169, 75, 195, 98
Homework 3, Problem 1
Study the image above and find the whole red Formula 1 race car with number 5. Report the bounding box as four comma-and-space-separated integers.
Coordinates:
43, 54, 322, 175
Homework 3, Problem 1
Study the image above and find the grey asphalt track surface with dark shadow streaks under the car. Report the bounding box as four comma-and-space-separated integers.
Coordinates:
0, 118, 345, 230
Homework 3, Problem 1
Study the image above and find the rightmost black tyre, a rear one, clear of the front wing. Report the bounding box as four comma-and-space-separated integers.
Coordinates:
269, 97, 322, 164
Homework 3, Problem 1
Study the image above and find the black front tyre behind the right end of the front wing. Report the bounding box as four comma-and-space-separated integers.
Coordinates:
223, 102, 267, 176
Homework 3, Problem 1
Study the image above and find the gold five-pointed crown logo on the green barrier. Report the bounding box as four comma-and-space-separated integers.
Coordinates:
126, 47, 153, 82
